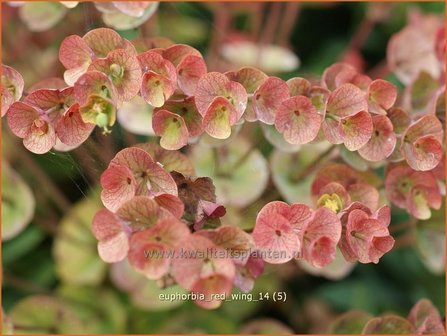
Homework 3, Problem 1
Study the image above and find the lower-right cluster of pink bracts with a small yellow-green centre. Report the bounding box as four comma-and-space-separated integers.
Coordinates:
253, 164, 394, 267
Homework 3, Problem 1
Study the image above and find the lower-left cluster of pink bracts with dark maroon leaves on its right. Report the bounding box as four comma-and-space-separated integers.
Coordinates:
93, 144, 263, 308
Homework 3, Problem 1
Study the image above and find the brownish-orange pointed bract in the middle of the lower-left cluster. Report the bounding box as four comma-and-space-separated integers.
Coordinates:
116, 196, 175, 231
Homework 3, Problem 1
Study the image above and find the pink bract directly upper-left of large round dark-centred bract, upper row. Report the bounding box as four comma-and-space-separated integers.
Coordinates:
252, 77, 290, 125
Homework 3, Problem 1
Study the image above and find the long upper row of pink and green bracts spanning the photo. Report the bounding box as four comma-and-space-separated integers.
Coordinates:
3, 28, 443, 171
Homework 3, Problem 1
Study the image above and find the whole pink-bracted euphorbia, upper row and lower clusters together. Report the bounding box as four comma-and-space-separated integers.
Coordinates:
2, 17, 444, 308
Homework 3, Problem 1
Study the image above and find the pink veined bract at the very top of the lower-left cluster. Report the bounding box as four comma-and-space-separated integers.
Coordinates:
110, 147, 177, 196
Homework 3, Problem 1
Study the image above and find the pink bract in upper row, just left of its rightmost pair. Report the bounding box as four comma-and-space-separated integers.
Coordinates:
358, 115, 396, 161
